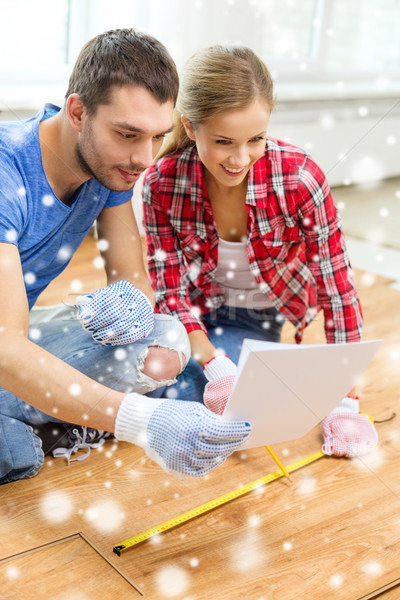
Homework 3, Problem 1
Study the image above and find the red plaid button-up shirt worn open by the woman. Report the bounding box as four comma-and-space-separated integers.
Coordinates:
143, 138, 362, 343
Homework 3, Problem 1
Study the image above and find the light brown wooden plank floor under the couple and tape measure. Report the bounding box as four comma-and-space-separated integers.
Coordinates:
0, 232, 400, 600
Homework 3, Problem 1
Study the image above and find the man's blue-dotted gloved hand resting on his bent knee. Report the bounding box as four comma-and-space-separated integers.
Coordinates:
75, 281, 154, 346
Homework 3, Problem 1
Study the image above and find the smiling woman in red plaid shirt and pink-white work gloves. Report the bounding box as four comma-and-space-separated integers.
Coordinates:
143, 46, 376, 456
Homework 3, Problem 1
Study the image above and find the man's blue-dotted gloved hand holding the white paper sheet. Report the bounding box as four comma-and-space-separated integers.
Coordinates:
115, 393, 251, 479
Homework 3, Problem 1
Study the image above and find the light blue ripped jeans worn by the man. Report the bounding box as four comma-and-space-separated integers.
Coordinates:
0, 309, 190, 484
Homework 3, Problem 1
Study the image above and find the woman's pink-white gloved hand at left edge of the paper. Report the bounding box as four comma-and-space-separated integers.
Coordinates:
203, 355, 237, 415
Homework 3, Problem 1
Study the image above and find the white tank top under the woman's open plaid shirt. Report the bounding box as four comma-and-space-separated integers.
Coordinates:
215, 238, 273, 310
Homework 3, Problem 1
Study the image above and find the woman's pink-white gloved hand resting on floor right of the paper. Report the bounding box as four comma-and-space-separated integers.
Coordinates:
321, 397, 378, 458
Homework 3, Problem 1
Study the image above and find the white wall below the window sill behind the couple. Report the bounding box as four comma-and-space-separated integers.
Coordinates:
0, 98, 400, 234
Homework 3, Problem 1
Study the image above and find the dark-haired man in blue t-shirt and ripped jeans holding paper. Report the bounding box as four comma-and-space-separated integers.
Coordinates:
0, 29, 250, 483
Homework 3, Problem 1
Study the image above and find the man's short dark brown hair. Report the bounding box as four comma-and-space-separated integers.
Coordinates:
65, 29, 179, 114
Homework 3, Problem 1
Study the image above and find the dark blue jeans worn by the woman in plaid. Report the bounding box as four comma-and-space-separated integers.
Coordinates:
149, 305, 284, 402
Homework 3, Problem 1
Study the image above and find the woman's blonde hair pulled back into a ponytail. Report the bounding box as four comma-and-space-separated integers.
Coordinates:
157, 45, 275, 158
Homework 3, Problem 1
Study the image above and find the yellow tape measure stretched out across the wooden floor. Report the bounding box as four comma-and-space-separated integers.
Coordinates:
113, 452, 325, 556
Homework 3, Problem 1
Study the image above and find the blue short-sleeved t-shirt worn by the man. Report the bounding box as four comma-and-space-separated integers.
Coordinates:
0, 104, 132, 308
